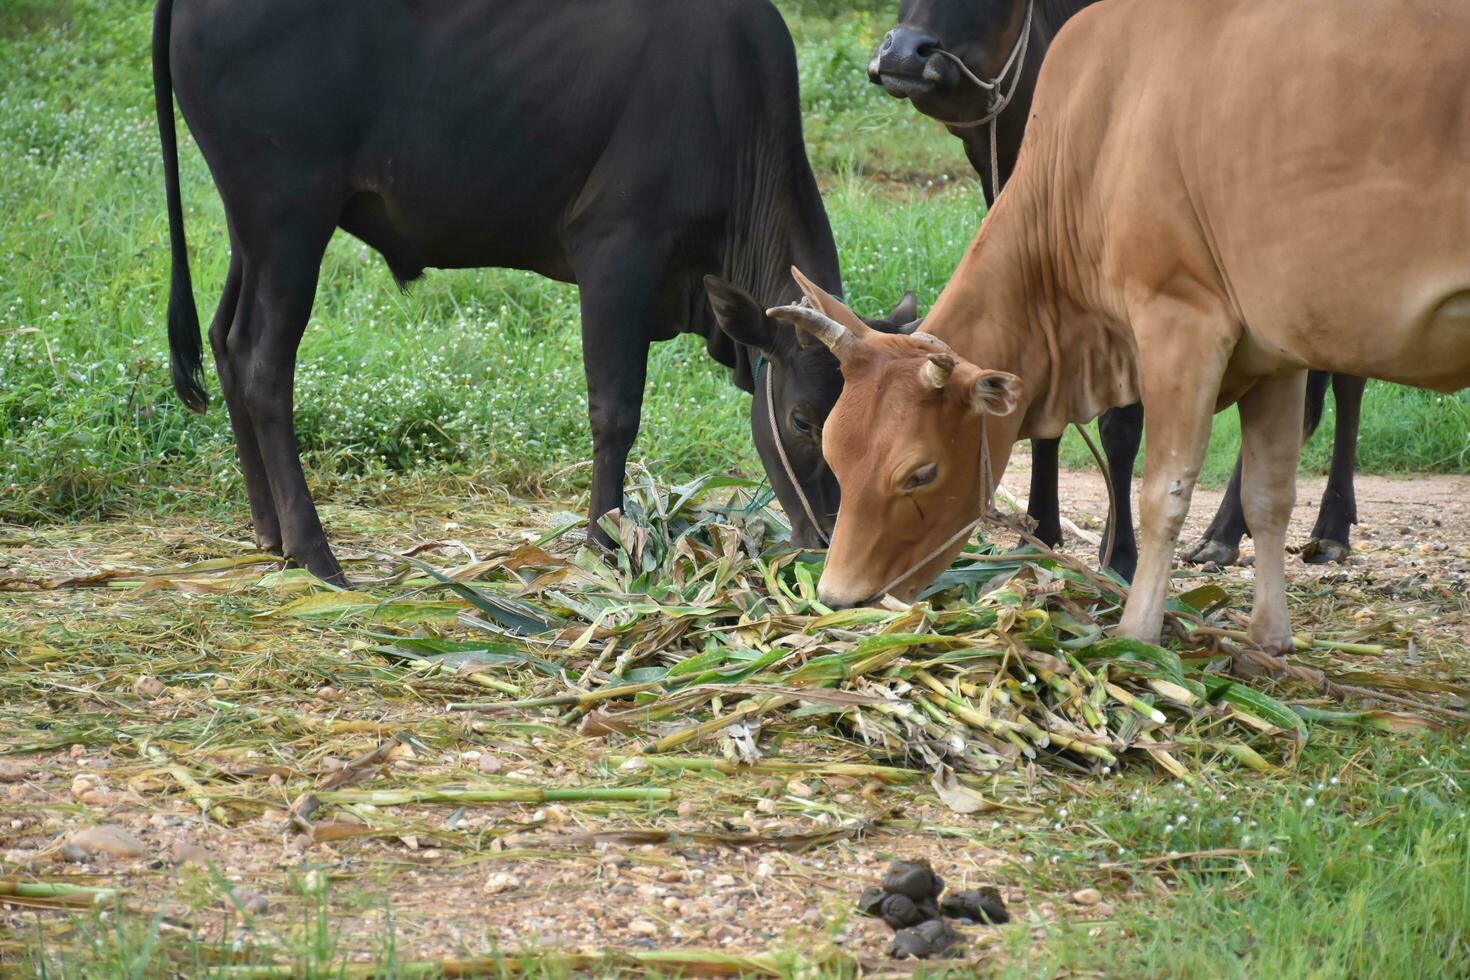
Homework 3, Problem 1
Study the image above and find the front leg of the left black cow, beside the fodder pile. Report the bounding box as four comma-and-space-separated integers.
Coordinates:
575, 239, 662, 548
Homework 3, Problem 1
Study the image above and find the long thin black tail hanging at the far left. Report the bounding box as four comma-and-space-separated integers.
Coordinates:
153, 0, 209, 411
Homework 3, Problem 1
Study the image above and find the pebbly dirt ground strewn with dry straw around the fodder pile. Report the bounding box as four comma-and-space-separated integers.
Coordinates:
0, 457, 1470, 970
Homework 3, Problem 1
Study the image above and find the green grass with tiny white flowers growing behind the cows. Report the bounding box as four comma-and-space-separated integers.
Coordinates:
0, 0, 1470, 522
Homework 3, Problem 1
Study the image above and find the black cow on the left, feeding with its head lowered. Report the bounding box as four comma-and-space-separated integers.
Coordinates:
153, 0, 905, 582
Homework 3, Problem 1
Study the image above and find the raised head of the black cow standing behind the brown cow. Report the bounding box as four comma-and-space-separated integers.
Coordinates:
867, 0, 1028, 120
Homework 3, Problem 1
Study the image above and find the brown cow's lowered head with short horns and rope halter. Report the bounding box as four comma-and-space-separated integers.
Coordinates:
770, 272, 1020, 608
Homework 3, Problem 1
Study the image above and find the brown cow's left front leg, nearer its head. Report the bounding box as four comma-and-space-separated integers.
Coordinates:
1119, 323, 1229, 644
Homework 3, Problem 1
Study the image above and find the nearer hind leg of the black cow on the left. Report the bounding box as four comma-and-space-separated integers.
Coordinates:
223, 225, 345, 585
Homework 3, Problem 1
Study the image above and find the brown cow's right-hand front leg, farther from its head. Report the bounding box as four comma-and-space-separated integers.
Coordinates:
1241, 372, 1307, 654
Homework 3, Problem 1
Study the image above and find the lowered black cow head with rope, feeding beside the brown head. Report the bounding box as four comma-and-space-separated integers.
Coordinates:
704, 276, 919, 548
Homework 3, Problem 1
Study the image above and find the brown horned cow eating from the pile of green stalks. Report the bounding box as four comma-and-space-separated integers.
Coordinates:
781, 0, 1470, 649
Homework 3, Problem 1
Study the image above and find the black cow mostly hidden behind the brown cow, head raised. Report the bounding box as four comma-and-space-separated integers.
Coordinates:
869, 0, 1364, 577
